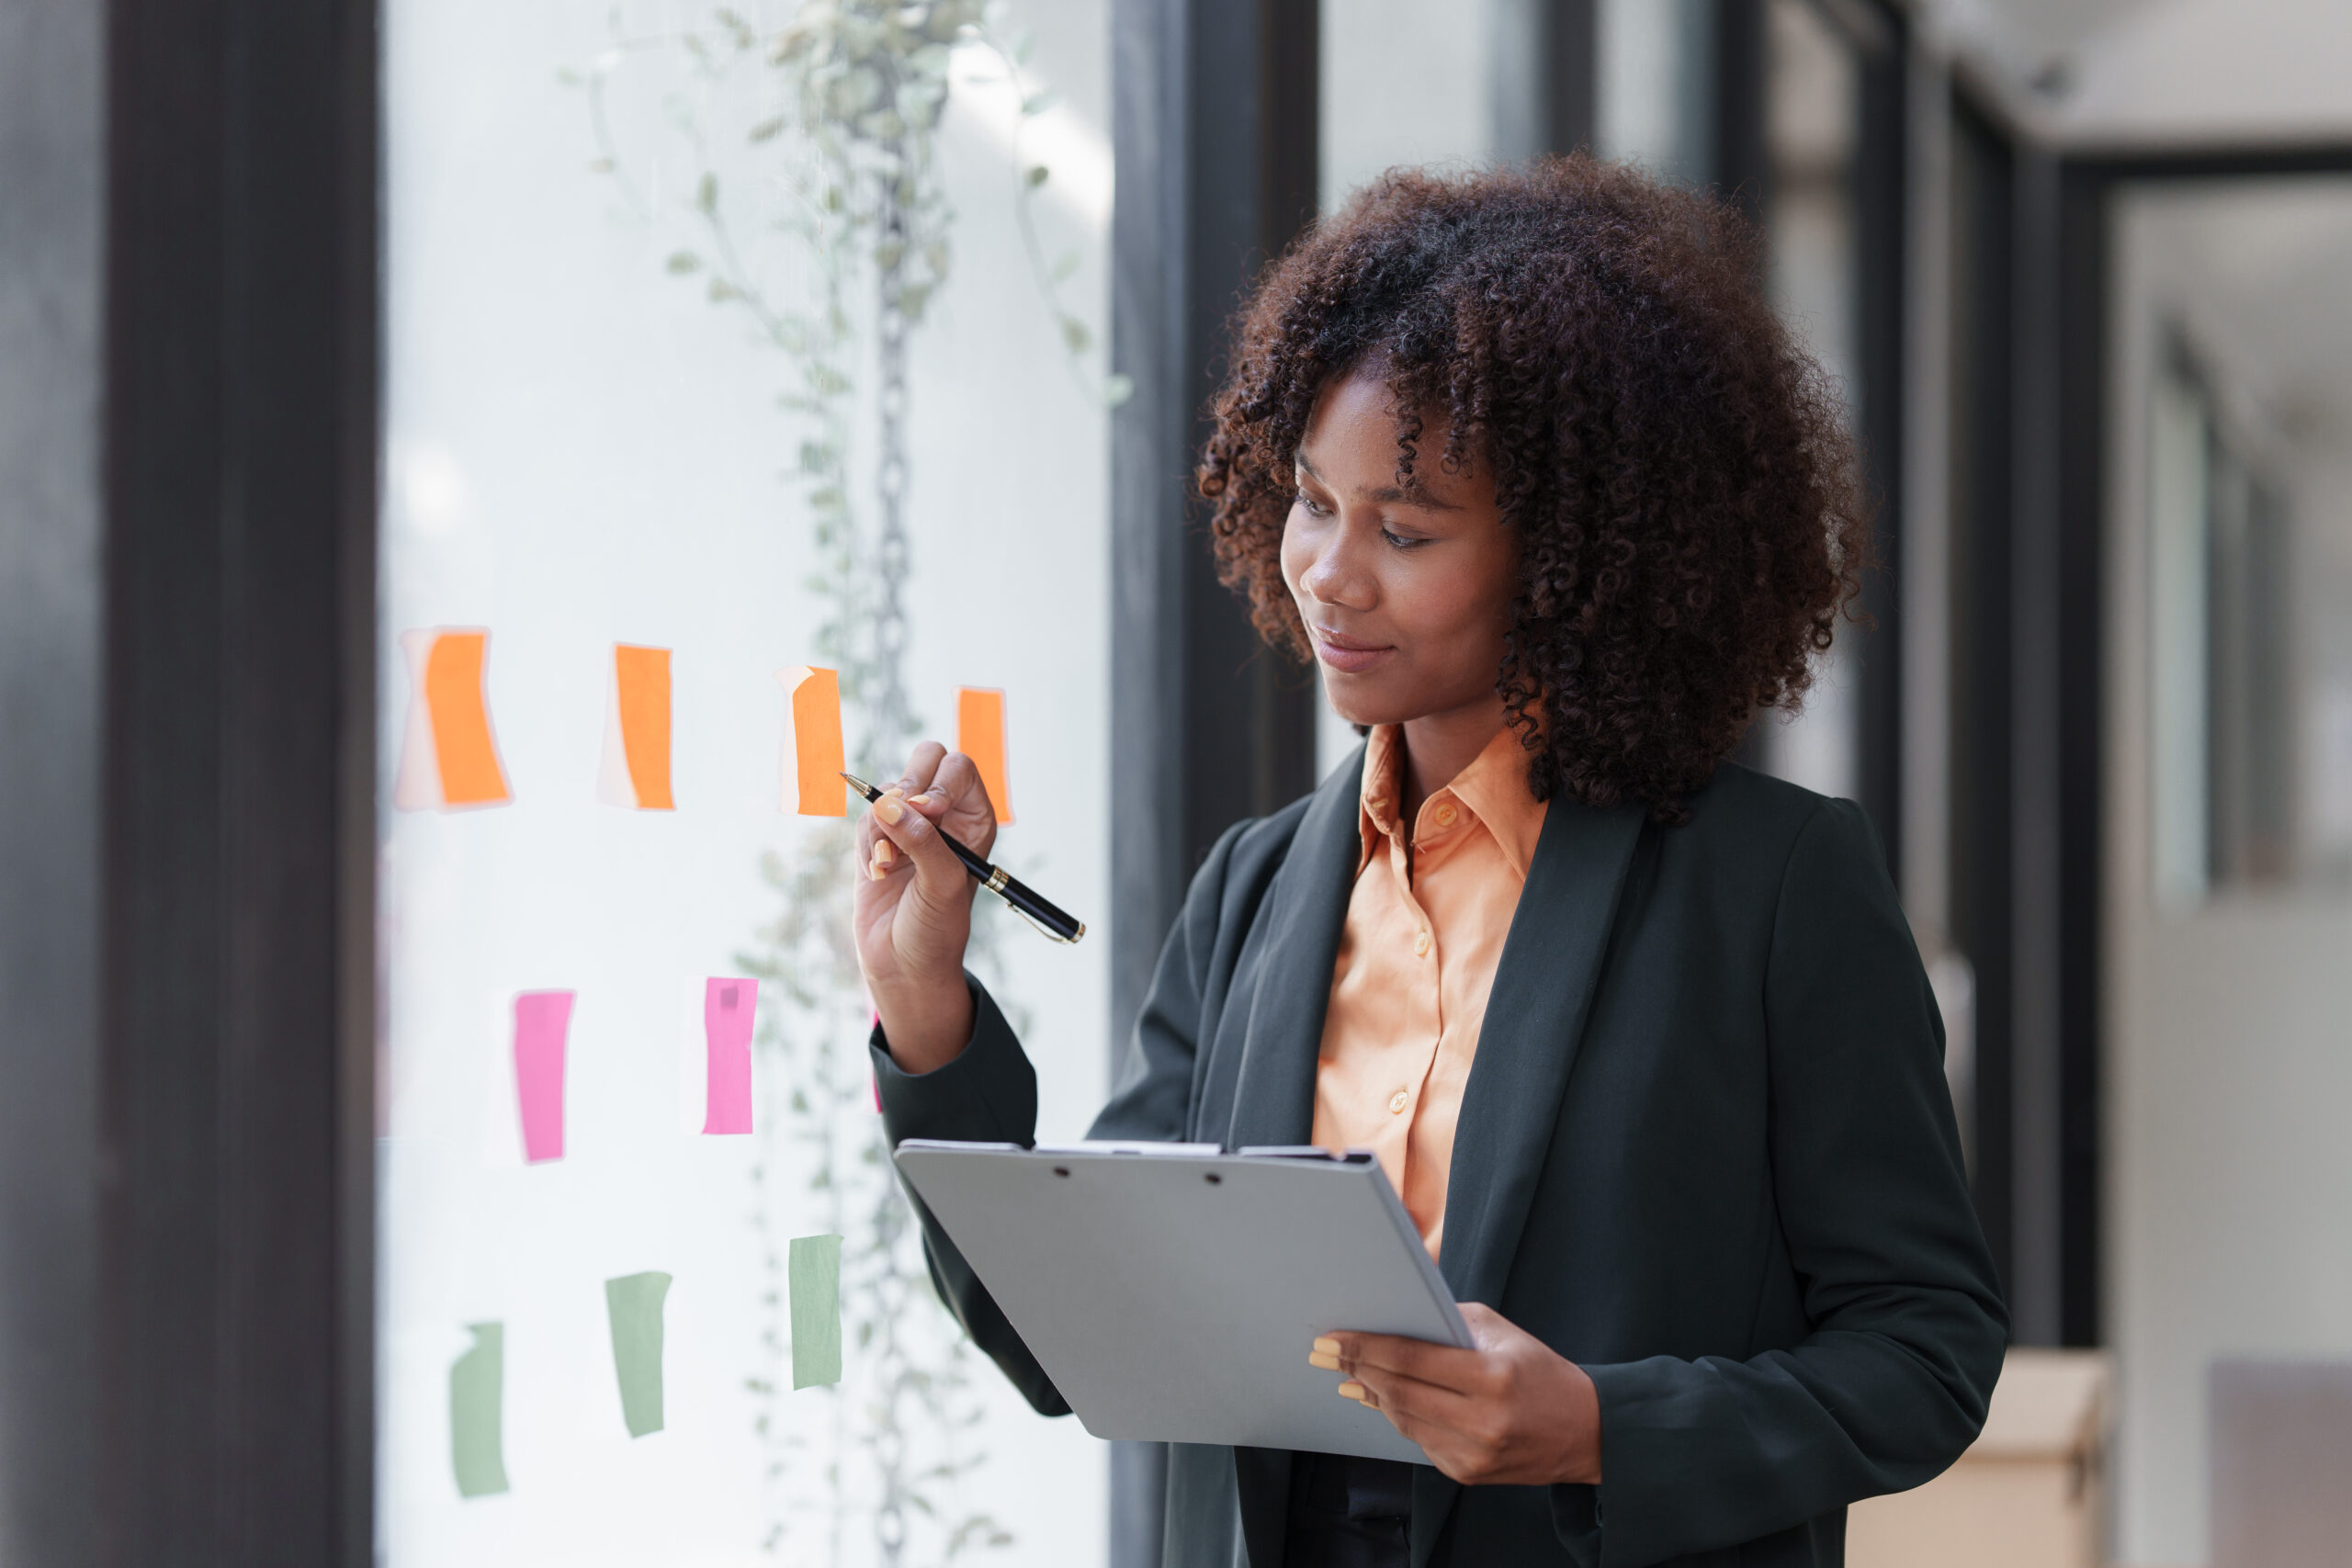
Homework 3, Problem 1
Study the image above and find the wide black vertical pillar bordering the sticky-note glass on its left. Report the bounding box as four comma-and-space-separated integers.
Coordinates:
96, 0, 377, 1568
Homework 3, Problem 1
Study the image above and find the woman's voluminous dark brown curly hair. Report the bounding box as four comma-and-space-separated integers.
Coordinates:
1197, 155, 1870, 823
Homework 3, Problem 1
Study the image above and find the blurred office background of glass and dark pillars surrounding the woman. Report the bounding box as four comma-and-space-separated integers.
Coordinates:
0, 0, 2352, 1568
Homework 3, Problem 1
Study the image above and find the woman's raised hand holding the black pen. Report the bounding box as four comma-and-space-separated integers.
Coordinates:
852, 740, 997, 1072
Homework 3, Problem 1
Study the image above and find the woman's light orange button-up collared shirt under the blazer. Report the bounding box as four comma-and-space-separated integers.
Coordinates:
1312, 724, 1543, 1258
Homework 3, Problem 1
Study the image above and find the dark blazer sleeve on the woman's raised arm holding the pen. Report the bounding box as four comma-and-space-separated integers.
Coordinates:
868, 825, 1239, 1416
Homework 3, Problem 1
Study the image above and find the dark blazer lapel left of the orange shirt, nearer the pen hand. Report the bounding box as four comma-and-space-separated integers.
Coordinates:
1226, 752, 1364, 1149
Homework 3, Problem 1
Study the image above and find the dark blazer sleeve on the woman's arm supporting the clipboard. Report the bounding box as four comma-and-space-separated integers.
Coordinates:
1555, 802, 2008, 1568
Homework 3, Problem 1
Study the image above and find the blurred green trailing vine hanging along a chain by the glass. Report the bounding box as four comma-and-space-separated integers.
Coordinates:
564, 0, 1101, 1565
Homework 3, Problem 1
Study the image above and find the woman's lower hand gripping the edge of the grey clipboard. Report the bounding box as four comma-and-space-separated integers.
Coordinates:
1307, 1303, 1601, 1485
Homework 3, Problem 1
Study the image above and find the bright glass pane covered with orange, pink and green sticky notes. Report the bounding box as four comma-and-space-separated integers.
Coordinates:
379, 0, 1114, 1568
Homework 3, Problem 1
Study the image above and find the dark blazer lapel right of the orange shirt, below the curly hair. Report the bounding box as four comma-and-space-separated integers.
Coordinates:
1440, 799, 1644, 1304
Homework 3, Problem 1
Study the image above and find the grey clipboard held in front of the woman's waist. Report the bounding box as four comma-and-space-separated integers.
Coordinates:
896, 1138, 1470, 1464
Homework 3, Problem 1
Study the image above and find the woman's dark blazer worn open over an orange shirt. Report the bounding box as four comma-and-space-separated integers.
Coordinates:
875, 751, 2007, 1568
